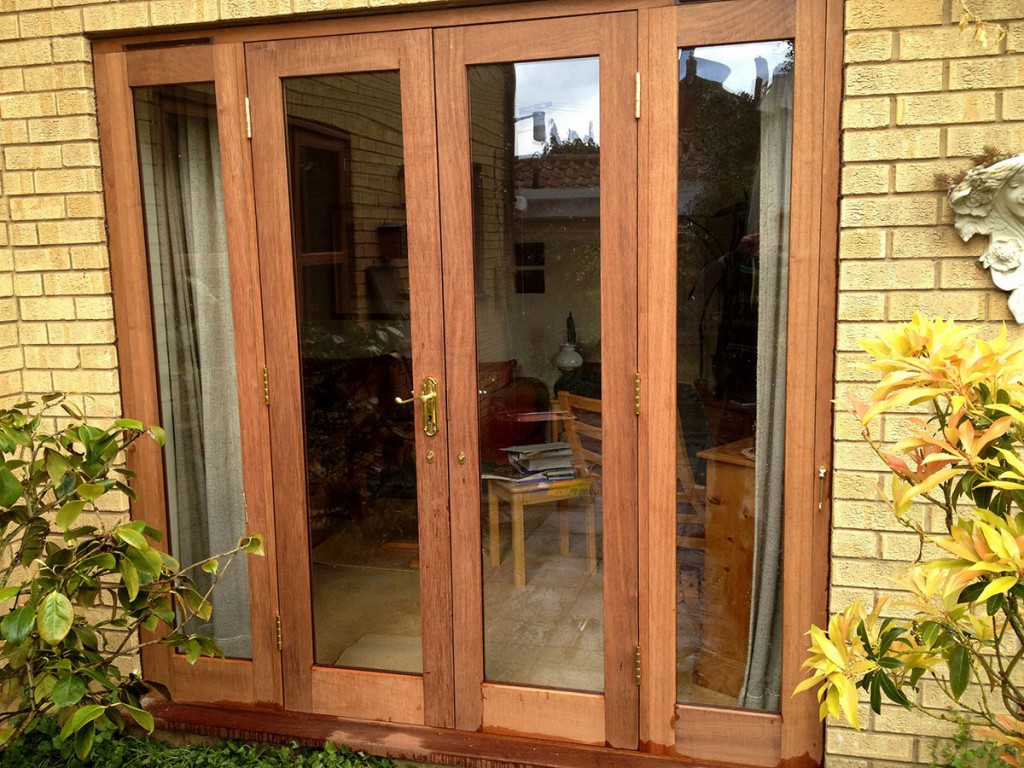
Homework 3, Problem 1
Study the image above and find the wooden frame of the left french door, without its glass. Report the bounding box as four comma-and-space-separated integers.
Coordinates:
246, 30, 455, 727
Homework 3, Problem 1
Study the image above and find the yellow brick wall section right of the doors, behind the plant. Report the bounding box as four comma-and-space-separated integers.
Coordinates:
826, 0, 1024, 768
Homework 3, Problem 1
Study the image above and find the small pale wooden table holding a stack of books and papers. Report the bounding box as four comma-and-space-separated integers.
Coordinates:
487, 477, 597, 589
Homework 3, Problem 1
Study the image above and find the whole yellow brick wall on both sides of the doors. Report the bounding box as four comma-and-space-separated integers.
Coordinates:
0, 0, 1024, 768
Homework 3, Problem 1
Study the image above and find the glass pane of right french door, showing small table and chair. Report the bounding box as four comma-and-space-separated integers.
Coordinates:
469, 58, 604, 691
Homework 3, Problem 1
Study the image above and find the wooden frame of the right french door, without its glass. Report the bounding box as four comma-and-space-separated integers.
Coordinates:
435, 13, 639, 749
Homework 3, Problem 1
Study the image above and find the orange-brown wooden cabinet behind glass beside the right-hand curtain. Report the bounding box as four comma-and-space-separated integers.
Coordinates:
693, 437, 754, 696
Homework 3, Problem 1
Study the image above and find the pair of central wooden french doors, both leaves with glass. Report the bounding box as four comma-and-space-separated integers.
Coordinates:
247, 13, 639, 749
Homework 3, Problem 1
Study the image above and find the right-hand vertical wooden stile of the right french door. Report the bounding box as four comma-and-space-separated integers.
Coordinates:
600, 13, 639, 750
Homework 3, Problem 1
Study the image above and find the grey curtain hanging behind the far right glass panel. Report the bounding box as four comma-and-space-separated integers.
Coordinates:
739, 73, 793, 710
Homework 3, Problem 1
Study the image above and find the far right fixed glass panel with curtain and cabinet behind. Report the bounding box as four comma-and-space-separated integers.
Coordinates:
676, 41, 793, 711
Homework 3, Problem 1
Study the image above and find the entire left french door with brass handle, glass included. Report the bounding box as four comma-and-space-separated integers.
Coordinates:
247, 31, 454, 726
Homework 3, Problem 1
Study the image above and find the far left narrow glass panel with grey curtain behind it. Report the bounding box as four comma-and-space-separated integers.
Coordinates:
134, 84, 252, 658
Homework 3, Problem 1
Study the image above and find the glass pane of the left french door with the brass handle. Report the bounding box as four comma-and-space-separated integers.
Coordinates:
285, 72, 423, 673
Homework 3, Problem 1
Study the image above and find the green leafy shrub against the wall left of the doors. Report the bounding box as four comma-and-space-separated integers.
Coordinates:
0, 394, 263, 760
